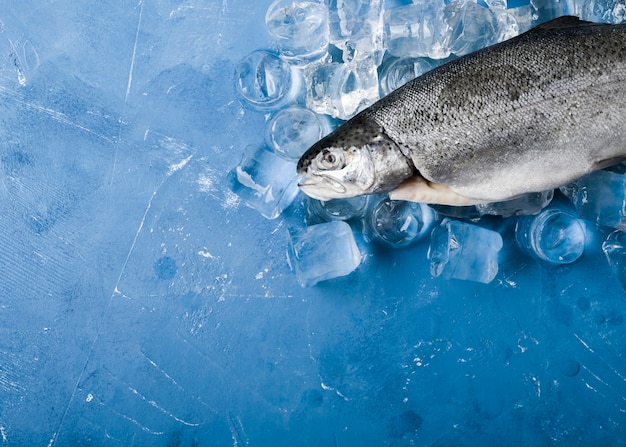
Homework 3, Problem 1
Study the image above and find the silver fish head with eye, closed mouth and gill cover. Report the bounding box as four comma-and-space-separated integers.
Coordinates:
297, 115, 414, 201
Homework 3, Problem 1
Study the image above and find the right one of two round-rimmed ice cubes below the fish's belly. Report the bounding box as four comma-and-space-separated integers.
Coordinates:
515, 209, 585, 264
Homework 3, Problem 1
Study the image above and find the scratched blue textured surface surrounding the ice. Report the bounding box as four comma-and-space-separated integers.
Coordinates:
0, 0, 626, 446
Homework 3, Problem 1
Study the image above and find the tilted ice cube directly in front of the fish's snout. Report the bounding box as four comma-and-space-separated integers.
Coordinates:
228, 146, 299, 219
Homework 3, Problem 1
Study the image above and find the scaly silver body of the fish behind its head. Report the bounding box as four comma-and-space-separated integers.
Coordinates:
363, 17, 626, 201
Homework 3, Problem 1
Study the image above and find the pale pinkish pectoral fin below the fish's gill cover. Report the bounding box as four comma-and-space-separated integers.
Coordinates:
389, 175, 485, 206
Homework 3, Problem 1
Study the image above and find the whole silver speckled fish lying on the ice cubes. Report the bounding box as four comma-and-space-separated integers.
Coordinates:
296, 16, 626, 206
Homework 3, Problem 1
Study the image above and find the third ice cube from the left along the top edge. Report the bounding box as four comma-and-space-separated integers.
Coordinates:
383, 0, 450, 59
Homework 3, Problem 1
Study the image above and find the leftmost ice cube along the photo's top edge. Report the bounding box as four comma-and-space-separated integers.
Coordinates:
265, 0, 329, 63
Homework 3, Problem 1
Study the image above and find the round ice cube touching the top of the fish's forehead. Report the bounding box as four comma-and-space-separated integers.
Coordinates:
265, 107, 331, 161
